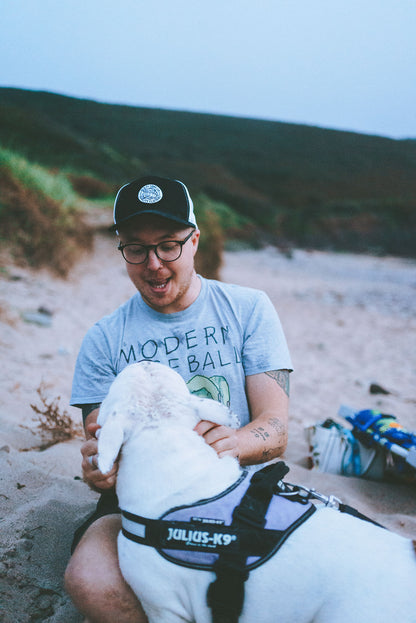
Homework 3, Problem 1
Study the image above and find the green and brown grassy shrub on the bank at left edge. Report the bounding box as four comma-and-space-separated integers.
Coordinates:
0, 150, 92, 277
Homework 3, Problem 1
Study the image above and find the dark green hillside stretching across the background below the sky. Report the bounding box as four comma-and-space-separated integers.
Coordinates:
0, 88, 416, 272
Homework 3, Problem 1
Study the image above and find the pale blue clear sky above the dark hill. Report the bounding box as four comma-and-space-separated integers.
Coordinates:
0, 0, 416, 138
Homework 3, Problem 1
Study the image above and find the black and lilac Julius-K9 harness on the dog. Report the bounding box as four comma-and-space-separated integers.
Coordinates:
121, 462, 316, 623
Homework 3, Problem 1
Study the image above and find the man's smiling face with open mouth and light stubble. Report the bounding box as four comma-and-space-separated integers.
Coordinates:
119, 214, 200, 314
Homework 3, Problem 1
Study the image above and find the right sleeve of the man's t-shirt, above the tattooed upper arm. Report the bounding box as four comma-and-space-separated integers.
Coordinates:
243, 292, 293, 376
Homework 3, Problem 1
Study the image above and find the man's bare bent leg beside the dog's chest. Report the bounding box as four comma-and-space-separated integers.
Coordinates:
65, 515, 147, 623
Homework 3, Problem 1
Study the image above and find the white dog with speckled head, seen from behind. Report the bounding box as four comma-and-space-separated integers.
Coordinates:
98, 362, 416, 623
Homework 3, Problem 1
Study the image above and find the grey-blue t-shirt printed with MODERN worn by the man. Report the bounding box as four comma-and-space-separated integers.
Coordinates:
71, 277, 292, 425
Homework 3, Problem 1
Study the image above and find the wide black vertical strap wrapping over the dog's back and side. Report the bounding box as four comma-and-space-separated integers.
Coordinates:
207, 461, 289, 623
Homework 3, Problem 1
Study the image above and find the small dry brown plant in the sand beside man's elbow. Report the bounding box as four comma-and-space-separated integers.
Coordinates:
24, 383, 82, 450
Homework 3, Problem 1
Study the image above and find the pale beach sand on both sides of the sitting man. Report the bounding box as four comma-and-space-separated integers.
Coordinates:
0, 236, 416, 623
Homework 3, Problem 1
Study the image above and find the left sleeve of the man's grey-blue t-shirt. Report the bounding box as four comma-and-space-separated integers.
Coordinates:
70, 324, 117, 406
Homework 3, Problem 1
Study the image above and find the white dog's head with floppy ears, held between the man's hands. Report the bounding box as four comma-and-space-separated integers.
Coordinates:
98, 361, 239, 474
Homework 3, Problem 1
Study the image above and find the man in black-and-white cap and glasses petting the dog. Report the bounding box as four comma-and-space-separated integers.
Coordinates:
65, 176, 291, 623
